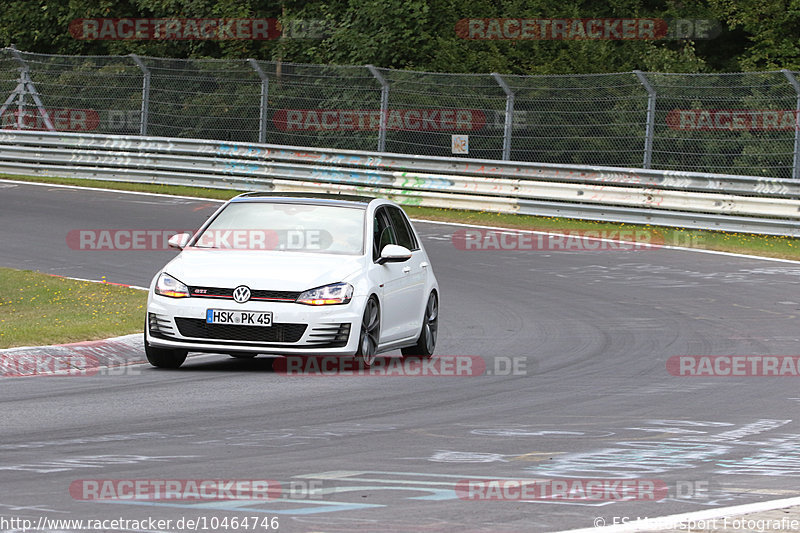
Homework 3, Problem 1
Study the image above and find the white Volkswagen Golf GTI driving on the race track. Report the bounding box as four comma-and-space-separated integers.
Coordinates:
145, 193, 439, 368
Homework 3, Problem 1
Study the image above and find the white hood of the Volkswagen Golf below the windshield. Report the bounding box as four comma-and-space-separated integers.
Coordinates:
163, 249, 364, 291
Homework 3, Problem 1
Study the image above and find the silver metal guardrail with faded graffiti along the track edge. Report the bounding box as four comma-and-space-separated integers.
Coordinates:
0, 131, 800, 236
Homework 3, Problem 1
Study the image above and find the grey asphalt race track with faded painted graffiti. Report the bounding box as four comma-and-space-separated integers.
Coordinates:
0, 183, 800, 532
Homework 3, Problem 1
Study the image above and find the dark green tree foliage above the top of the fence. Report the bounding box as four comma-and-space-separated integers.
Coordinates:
0, 0, 800, 74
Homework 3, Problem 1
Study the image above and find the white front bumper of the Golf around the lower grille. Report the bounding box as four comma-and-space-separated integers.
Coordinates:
145, 293, 364, 355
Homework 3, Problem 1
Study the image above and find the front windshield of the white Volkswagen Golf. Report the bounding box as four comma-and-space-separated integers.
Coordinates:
192, 202, 365, 255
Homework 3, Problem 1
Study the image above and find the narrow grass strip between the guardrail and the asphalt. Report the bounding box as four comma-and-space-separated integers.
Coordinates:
0, 174, 800, 260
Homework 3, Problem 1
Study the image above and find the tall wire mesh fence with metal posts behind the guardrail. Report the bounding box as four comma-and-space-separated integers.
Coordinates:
0, 47, 800, 179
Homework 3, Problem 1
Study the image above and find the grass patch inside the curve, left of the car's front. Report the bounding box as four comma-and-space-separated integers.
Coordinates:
0, 268, 147, 348
